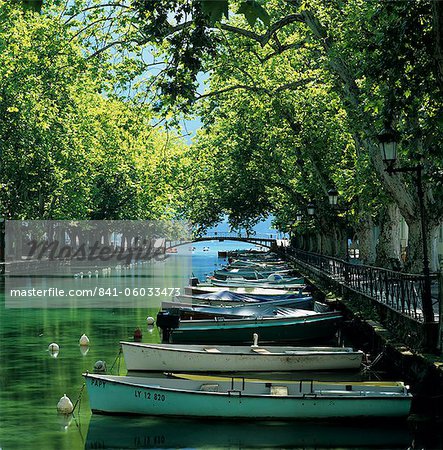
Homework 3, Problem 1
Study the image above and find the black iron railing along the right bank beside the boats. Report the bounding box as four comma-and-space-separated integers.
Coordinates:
286, 247, 438, 322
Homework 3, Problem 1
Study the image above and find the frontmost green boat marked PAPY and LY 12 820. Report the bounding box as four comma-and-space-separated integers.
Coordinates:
83, 373, 412, 420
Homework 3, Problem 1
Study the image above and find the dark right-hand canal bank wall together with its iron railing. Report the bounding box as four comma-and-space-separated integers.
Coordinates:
278, 247, 443, 427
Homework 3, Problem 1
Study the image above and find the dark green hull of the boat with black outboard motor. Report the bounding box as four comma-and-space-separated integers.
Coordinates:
164, 311, 341, 344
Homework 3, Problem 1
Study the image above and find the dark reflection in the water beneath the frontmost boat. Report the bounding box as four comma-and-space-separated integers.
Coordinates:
85, 415, 412, 450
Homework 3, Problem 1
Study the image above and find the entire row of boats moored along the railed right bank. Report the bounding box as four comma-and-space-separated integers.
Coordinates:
84, 254, 412, 420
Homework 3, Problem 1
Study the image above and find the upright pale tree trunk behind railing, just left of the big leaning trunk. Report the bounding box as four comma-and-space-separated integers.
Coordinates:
376, 203, 402, 270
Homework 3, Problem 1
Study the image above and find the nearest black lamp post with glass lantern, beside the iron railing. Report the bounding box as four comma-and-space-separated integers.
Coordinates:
377, 124, 434, 322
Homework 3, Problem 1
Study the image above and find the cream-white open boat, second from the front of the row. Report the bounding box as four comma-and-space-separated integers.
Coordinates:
120, 342, 363, 372
